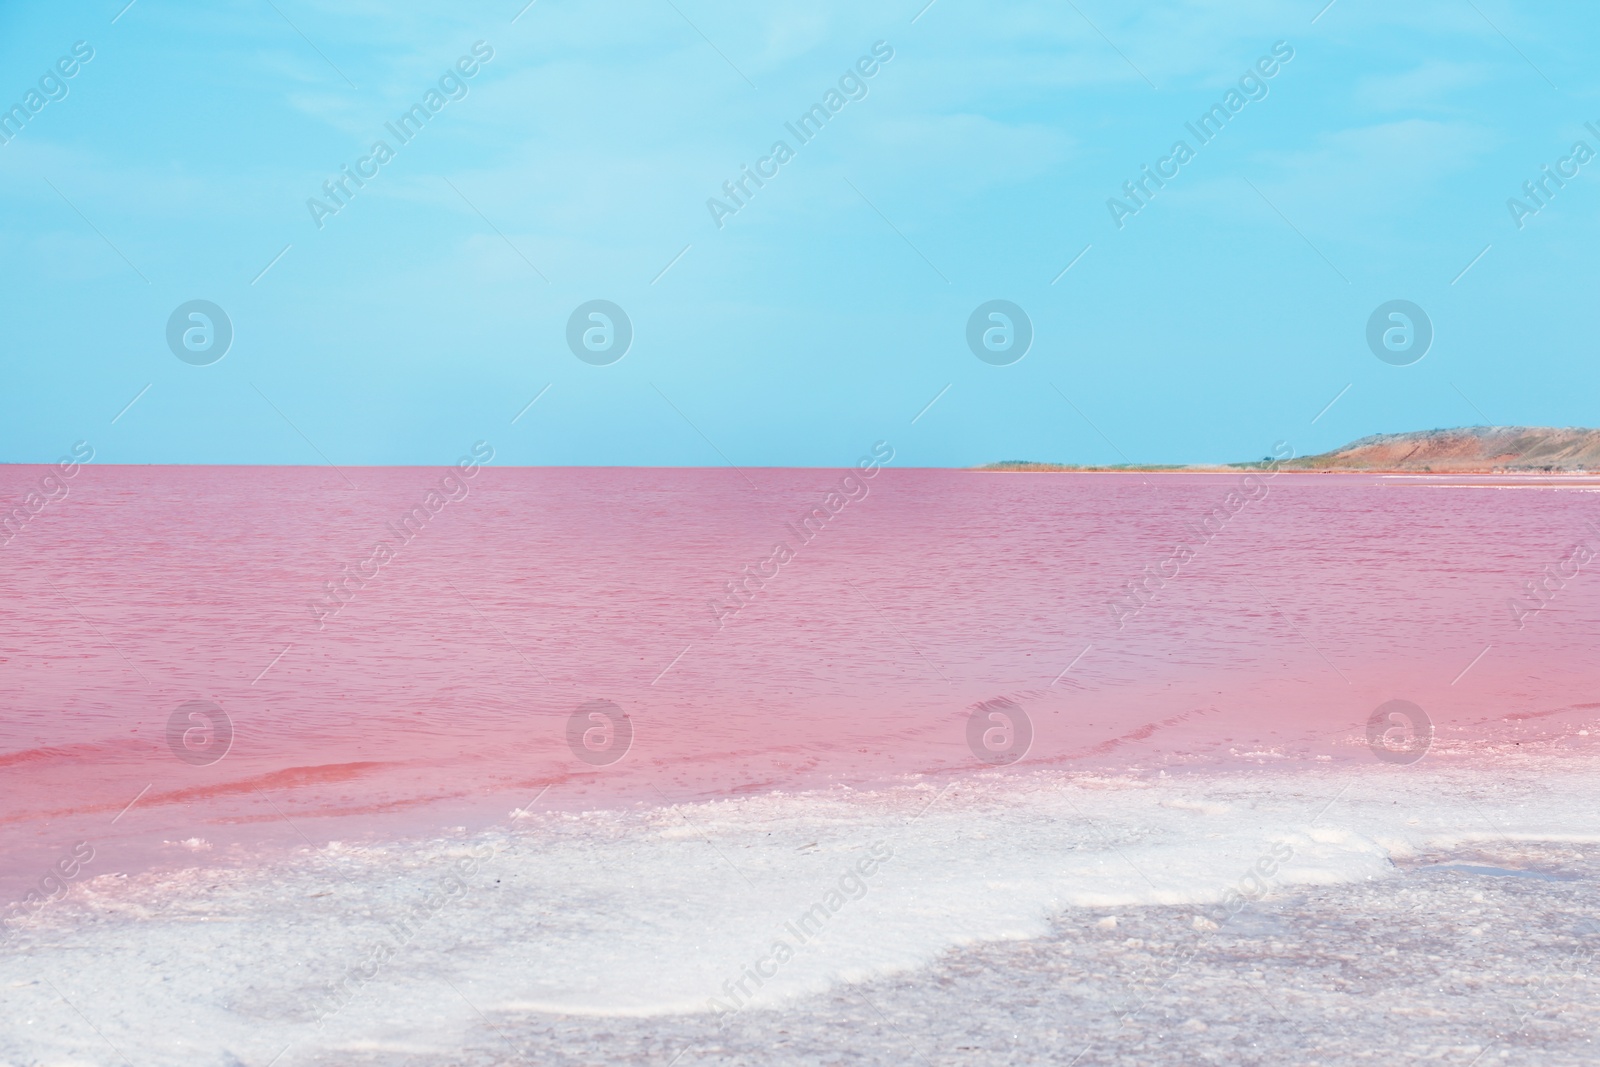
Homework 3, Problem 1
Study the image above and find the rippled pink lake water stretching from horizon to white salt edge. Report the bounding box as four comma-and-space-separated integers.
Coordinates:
0, 466, 1600, 901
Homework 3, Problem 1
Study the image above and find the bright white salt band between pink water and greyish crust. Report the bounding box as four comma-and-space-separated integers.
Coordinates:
0, 760, 1600, 1067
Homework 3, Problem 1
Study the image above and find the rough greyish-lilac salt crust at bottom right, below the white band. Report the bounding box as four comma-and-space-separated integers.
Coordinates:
318, 843, 1600, 1067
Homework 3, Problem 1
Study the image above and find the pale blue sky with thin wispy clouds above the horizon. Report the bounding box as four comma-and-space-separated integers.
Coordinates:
0, 0, 1600, 466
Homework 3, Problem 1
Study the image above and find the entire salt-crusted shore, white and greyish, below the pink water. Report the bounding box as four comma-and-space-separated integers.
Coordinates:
0, 753, 1600, 1067
